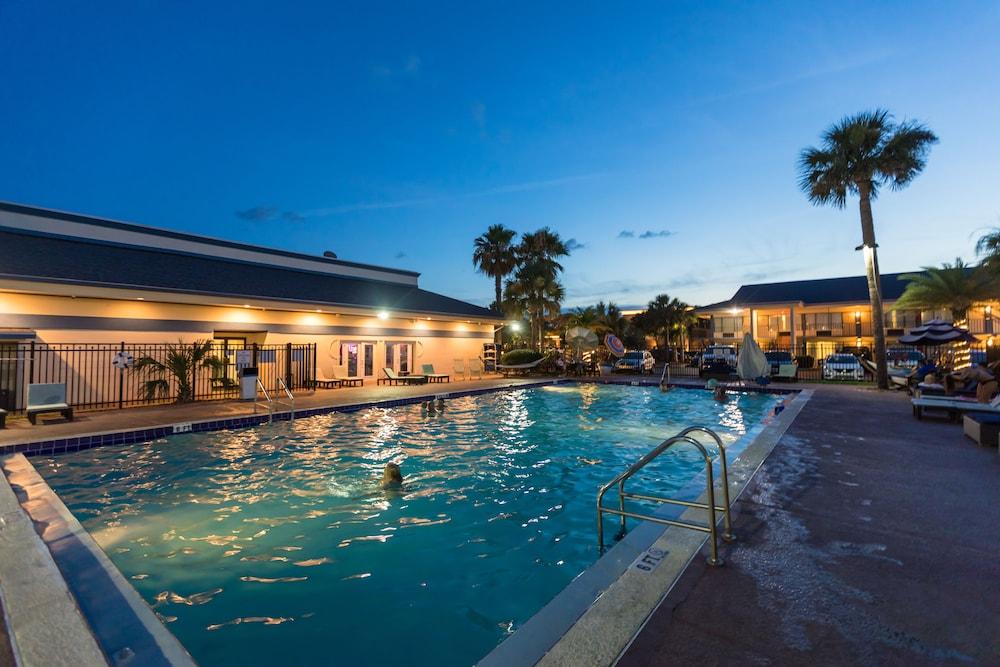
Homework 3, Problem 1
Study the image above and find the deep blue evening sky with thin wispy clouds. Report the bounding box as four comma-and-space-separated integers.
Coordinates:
0, 0, 1000, 307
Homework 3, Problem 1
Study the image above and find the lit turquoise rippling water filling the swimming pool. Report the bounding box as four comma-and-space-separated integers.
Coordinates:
36, 385, 778, 665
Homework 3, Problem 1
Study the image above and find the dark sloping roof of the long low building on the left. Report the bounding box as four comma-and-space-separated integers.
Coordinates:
0, 226, 498, 320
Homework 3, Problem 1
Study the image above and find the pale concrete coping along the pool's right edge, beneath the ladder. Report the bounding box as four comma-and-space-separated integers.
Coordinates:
477, 383, 813, 667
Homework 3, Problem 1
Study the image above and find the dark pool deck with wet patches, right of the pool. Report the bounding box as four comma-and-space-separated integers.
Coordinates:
618, 385, 1000, 667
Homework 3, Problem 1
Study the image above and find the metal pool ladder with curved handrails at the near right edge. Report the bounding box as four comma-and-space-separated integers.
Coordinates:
597, 426, 736, 566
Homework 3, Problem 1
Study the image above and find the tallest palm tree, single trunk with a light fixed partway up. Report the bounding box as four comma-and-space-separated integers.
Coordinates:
799, 109, 938, 389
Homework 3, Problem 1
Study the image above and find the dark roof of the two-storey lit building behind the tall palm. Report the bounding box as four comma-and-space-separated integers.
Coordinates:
698, 273, 920, 311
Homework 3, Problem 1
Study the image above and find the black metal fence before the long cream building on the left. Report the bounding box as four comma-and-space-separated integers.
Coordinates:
0, 342, 316, 413
